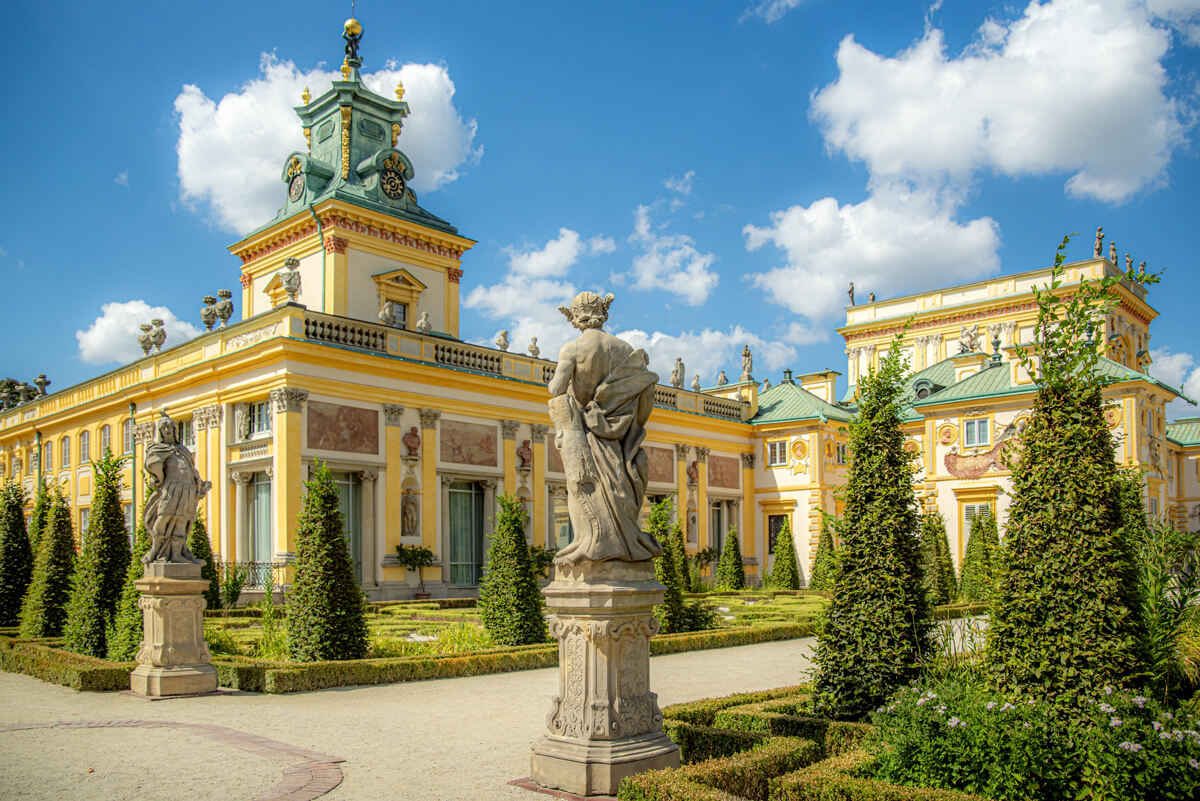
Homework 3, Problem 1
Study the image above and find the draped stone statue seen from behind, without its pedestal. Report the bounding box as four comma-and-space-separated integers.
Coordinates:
550, 293, 662, 565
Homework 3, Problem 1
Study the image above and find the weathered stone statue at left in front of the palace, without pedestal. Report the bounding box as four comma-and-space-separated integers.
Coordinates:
142, 412, 212, 565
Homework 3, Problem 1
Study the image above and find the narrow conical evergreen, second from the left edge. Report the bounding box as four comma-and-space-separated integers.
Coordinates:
20, 488, 76, 637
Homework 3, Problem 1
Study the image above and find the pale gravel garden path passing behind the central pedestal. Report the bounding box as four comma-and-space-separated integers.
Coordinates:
0, 639, 814, 801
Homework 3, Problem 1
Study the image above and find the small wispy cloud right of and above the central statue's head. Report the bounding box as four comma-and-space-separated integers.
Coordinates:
629, 205, 719, 306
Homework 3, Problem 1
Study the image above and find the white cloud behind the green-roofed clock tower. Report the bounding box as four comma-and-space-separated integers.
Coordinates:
175, 54, 482, 234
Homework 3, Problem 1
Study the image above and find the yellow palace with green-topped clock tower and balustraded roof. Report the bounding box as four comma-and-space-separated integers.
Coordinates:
0, 23, 1200, 600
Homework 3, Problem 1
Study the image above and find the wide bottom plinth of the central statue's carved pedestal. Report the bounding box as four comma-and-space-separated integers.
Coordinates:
533, 731, 679, 795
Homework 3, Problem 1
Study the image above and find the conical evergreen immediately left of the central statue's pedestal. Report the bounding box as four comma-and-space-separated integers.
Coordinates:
479, 493, 550, 645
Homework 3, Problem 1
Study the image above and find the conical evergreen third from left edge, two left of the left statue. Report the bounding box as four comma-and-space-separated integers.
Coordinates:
62, 453, 130, 658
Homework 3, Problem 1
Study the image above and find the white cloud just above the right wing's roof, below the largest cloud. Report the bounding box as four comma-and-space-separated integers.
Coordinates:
743, 185, 1000, 323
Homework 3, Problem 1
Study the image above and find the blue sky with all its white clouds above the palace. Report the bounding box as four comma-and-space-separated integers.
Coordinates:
0, 0, 1200, 419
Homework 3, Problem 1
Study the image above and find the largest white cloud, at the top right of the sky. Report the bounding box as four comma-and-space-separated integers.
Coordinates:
811, 0, 1183, 203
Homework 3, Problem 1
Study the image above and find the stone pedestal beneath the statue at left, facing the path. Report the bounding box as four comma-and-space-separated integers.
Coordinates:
130, 562, 217, 698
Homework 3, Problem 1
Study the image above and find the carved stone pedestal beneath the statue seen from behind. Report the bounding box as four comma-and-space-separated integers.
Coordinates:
533, 561, 679, 795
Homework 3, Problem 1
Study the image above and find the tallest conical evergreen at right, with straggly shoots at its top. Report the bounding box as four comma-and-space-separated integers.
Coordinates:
988, 237, 1157, 704
